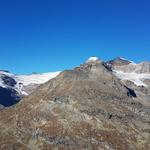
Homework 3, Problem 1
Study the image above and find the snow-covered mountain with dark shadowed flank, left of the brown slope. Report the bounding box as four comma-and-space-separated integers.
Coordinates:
0, 70, 60, 108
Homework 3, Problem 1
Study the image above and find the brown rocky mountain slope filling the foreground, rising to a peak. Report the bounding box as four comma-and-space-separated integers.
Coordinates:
0, 60, 150, 150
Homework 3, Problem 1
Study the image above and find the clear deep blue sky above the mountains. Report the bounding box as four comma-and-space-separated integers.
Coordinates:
0, 0, 150, 74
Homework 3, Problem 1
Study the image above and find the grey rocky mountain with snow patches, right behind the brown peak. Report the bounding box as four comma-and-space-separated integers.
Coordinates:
107, 57, 150, 87
